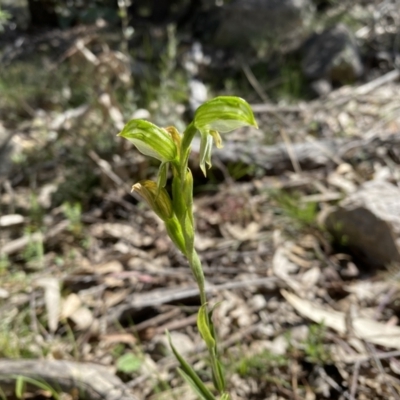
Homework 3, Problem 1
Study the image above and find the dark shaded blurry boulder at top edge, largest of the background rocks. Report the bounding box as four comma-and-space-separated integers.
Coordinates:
213, 0, 314, 49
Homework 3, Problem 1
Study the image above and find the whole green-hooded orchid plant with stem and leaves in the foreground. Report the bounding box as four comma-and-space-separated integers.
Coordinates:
119, 96, 257, 400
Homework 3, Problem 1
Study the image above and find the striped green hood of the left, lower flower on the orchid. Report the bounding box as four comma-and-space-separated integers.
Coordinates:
118, 119, 178, 162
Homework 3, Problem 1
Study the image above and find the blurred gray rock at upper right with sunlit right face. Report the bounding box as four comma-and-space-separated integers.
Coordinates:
303, 24, 364, 84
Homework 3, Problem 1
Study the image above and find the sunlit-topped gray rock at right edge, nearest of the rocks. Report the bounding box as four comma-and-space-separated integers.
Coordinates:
325, 180, 400, 266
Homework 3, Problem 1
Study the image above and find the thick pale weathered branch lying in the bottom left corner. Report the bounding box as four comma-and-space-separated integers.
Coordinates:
0, 359, 138, 400
